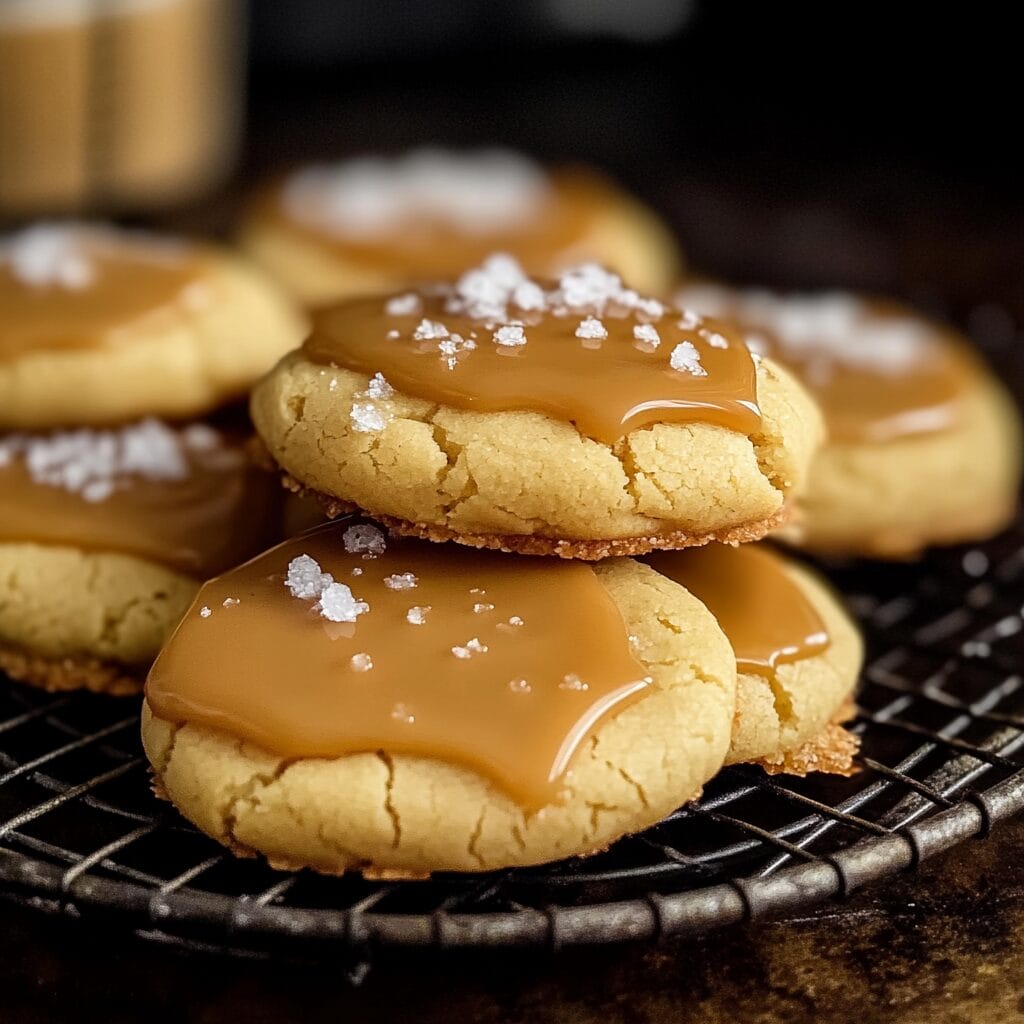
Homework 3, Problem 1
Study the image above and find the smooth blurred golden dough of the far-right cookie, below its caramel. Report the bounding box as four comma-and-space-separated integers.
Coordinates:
782, 374, 1021, 559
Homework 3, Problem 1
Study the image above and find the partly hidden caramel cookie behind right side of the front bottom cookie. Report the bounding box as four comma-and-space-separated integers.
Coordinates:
644, 545, 863, 774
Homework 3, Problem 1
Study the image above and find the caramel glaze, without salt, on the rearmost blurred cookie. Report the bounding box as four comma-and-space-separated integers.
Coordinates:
255, 168, 621, 281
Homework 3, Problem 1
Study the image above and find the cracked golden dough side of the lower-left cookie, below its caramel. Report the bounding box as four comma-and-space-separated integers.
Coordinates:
0, 543, 200, 694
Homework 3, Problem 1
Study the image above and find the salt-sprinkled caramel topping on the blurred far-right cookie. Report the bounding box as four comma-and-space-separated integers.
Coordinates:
680, 286, 977, 442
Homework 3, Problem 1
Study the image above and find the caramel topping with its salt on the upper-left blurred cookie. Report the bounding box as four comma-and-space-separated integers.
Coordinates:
0, 224, 205, 362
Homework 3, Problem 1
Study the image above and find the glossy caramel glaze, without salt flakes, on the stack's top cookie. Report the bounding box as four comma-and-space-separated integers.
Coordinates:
303, 296, 761, 444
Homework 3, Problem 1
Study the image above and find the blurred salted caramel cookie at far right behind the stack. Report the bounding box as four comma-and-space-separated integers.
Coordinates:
680, 286, 1021, 558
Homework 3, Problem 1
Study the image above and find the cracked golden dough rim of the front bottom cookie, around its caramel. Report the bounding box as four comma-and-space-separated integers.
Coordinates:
142, 559, 735, 877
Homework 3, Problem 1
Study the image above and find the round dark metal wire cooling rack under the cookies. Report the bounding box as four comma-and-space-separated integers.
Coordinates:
0, 317, 1024, 955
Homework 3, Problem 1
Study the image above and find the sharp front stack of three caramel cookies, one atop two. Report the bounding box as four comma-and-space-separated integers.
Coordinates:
143, 255, 860, 877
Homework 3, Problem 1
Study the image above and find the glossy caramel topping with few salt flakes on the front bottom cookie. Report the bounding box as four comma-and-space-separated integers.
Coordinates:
146, 519, 650, 810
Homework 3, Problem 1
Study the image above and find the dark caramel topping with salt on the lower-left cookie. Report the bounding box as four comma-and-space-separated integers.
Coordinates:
0, 421, 280, 580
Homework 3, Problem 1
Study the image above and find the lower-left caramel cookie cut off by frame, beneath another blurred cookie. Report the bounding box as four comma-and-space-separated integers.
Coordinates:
0, 420, 279, 693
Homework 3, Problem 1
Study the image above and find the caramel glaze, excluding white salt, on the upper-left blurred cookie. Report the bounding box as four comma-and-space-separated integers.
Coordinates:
0, 239, 205, 364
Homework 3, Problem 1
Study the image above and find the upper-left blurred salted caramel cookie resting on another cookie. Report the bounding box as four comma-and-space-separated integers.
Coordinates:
0, 223, 305, 430
